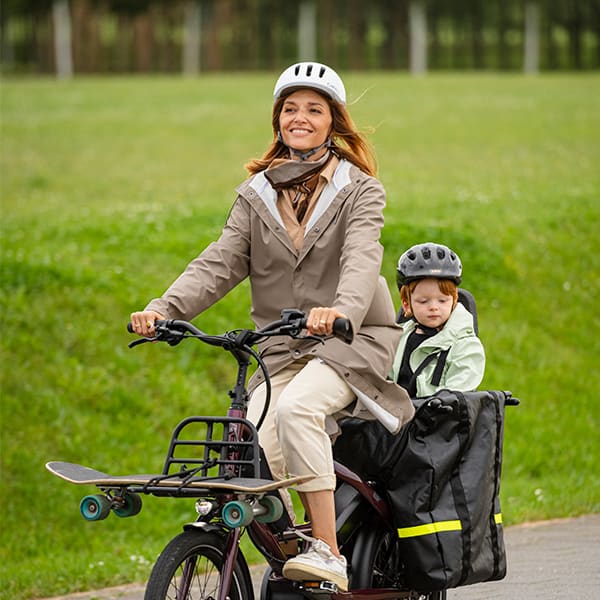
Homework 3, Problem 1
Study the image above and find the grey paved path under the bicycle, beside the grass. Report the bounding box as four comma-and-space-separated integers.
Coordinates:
41, 514, 600, 600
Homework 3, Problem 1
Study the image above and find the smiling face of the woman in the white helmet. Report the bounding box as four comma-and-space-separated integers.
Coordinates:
279, 89, 333, 160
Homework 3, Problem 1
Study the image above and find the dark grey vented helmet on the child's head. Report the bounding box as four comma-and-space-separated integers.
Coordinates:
396, 242, 462, 289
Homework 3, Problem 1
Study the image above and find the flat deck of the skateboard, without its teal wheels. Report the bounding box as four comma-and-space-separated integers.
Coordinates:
46, 461, 312, 494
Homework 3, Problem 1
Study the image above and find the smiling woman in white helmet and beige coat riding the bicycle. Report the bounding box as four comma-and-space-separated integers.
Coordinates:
131, 63, 413, 591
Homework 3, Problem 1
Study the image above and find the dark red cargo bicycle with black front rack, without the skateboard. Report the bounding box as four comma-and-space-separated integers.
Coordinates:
124, 310, 458, 600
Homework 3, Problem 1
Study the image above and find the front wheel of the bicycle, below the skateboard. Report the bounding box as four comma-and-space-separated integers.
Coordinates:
144, 531, 254, 600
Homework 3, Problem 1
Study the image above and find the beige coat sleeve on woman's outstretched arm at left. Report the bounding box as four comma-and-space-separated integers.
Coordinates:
146, 197, 250, 320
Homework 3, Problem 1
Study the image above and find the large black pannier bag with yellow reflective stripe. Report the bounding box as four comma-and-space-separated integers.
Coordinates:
334, 390, 510, 592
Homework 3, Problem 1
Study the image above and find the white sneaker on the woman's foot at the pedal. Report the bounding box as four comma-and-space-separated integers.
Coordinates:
283, 540, 348, 592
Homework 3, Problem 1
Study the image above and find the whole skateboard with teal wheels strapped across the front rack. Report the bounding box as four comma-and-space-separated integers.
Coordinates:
46, 461, 312, 527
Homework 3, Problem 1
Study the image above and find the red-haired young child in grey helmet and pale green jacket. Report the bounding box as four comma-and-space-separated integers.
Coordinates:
391, 242, 485, 397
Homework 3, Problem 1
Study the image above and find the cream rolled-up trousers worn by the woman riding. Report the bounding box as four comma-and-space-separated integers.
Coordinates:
248, 358, 355, 492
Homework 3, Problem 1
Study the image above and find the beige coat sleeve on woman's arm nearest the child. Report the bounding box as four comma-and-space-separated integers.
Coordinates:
334, 177, 386, 331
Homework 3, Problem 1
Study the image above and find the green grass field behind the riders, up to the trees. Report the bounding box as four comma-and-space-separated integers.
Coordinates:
0, 73, 600, 599
